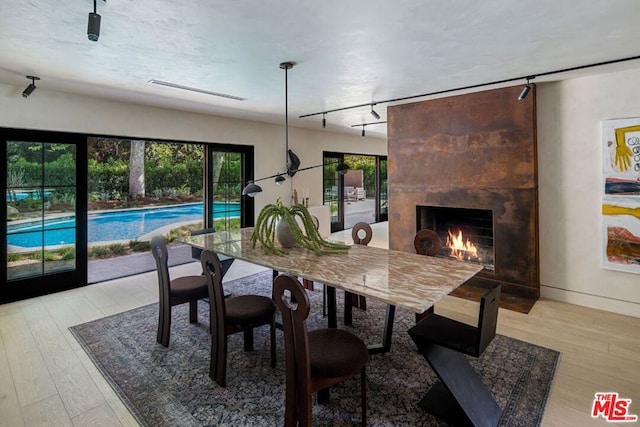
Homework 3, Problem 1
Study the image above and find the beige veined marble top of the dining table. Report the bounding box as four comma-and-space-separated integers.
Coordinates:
181, 228, 483, 313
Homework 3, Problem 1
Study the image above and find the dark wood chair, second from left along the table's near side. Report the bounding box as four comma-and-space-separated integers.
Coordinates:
201, 250, 276, 387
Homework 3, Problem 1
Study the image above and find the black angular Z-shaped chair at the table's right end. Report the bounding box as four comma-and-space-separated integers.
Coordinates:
409, 285, 501, 426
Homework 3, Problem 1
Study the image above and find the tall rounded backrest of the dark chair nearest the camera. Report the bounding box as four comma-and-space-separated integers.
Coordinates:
273, 273, 311, 389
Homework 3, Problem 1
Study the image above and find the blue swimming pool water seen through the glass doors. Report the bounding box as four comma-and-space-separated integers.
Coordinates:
7, 203, 240, 248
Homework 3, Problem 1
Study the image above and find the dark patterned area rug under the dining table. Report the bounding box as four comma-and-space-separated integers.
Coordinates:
70, 272, 559, 426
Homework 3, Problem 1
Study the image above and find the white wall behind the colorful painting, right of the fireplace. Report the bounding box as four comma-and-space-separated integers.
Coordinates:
537, 70, 640, 317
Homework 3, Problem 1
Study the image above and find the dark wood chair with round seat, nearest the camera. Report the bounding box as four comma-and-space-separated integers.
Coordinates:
273, 274, 369, 427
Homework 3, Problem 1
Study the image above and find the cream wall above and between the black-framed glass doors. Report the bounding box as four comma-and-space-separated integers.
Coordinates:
0, 84, 387, 215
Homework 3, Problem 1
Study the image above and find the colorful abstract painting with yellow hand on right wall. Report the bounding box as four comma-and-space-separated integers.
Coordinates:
602, 118, 640, 274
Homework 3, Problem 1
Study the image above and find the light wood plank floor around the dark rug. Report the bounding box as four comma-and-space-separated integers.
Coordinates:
0, 261, 640, 427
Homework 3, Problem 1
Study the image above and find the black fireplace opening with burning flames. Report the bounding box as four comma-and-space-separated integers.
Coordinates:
416, 206, 495, 271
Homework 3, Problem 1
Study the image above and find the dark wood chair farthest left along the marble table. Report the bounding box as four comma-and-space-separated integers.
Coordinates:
150, 236, 209, 347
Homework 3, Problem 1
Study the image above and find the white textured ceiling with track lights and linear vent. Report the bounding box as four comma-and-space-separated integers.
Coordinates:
0, 0, 640, 137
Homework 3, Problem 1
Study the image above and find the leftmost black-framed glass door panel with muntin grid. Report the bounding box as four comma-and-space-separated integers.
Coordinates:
0, 131, 87, 302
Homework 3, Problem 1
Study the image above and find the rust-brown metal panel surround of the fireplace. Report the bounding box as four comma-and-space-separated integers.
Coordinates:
387, 87, 540, 299
